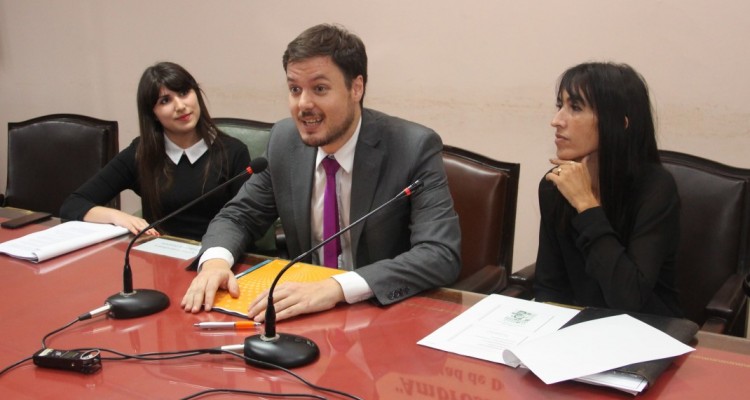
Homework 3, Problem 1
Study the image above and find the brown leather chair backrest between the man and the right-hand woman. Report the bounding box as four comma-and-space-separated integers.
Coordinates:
443, 145, 521, 291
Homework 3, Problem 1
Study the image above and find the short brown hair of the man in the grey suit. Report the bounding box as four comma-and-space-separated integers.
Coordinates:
282, 24, 367, 107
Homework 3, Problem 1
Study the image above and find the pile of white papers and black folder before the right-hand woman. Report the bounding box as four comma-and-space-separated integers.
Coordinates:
418, 295, 697, 394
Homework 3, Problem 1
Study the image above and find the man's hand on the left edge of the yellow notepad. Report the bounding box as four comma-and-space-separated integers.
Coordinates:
180, 258, 240, 313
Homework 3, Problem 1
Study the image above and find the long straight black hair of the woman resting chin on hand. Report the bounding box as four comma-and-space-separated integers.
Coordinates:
557, 62, 660, 243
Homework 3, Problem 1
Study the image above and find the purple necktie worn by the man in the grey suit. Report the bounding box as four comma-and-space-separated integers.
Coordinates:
323, 157, 341, 268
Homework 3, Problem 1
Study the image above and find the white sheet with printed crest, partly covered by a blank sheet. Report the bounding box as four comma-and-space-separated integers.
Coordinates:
417, 294, 578, 367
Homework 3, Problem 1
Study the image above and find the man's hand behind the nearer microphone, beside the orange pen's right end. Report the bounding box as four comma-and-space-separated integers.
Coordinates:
248, 278, 344, 322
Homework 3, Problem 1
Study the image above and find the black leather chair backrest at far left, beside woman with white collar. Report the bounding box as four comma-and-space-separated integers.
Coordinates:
3, 114, 120, 216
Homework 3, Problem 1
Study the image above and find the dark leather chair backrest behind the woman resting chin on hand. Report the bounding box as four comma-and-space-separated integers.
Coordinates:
659, 150, 750, 329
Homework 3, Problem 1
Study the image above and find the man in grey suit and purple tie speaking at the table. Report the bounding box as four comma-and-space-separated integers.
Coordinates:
182, 24, 461, 322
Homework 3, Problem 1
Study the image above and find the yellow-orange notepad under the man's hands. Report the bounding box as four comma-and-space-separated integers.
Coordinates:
213, 259, 345, 318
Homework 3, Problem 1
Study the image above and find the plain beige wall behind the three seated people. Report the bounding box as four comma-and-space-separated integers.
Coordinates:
0, 0, 750, 268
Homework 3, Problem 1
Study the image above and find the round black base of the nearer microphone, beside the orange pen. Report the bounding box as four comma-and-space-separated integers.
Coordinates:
244, 333, 320, 369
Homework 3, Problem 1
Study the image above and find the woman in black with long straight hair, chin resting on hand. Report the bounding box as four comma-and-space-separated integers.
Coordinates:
534, 63, 682, 316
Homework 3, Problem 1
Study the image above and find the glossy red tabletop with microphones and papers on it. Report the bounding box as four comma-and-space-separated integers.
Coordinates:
0, 211, 750, 400
